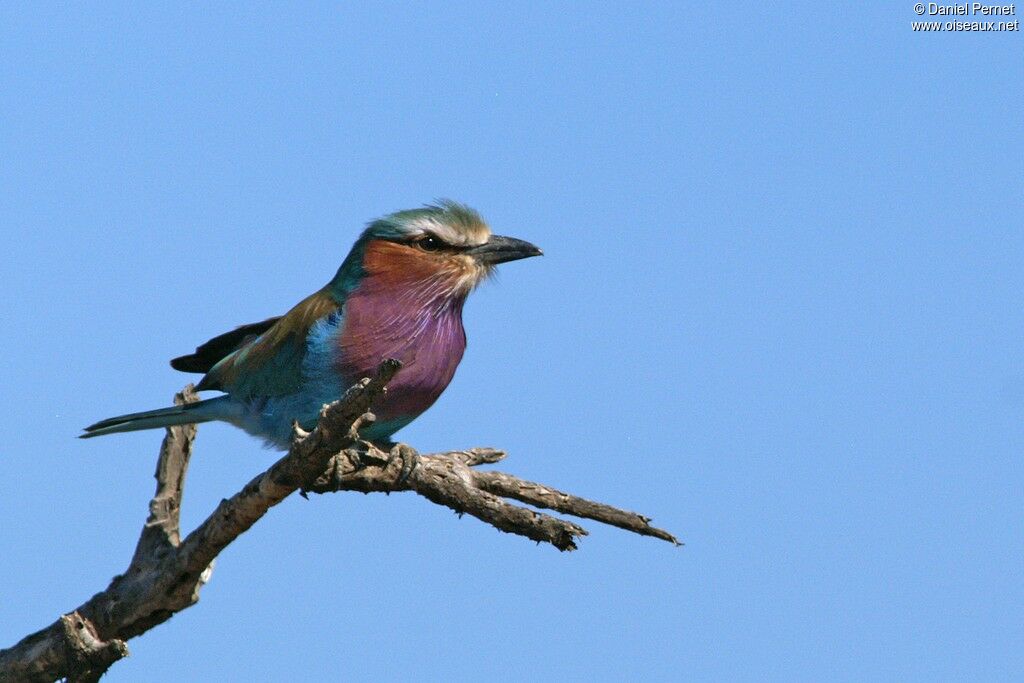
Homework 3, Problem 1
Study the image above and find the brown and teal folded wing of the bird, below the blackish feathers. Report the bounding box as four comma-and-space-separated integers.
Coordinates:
196, 290, 340, 399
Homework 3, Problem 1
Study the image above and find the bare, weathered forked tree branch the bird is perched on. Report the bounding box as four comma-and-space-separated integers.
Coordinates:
0, 360, 680, 683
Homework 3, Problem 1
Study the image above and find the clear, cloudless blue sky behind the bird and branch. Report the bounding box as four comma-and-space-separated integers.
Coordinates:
0, 2, 1024, 682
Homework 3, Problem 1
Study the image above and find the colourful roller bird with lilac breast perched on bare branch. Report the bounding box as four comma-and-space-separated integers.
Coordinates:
81, 200, 543, 451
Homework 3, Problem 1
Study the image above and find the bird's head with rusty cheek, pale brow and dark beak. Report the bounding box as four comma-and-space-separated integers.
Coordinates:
334, 201, 542, 297
